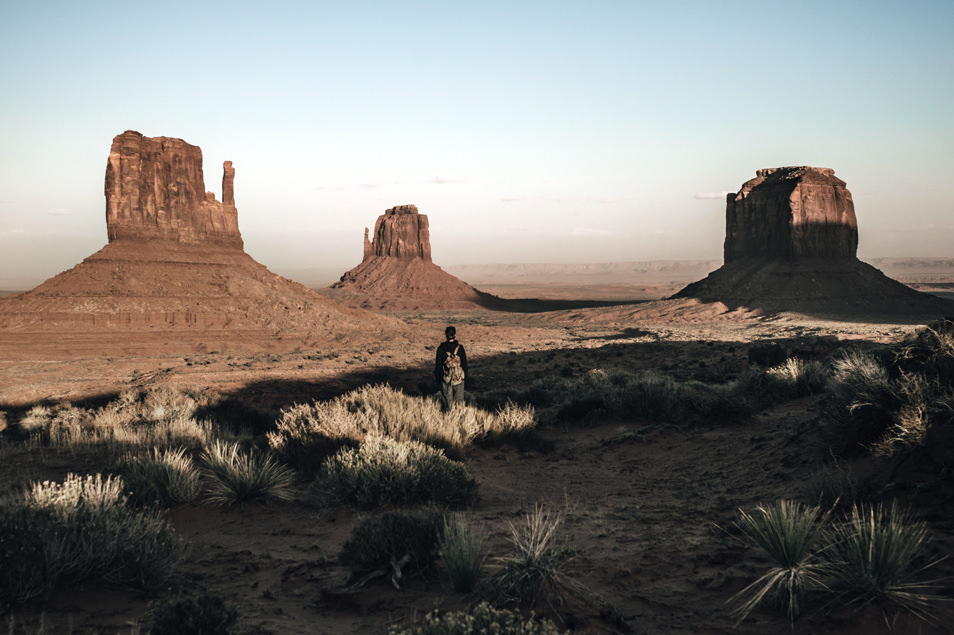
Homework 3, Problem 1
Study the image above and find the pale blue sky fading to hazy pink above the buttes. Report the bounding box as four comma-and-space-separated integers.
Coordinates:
0, 0, 954, 288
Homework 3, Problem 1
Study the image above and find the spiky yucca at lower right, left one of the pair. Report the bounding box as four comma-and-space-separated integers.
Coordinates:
729, 500, 828, 623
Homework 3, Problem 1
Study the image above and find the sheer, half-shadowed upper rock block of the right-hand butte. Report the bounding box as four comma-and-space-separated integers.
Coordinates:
725, 166, 858, 263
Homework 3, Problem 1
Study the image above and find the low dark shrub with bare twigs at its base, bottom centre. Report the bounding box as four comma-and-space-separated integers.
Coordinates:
338, 511, 443, 588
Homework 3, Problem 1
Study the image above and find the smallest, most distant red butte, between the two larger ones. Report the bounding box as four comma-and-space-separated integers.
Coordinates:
330, 205, 493, 310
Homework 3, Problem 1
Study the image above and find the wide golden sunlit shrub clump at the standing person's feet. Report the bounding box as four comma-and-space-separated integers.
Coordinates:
267, 384, 535, 473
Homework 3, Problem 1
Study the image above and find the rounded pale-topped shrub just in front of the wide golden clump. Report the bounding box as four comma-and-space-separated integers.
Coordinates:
312, 437, 478, 509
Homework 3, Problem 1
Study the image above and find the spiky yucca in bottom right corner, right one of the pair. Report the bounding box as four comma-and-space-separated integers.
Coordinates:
826, 503, 942, 621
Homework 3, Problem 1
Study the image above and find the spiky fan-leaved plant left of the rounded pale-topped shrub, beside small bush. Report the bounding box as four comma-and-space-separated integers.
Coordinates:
202, 441, 295, 507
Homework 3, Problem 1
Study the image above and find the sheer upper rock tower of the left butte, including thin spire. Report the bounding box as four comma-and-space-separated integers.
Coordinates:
106, 130, 243, 249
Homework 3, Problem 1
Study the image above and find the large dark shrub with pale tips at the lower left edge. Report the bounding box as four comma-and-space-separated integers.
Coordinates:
0, 474, 185, 602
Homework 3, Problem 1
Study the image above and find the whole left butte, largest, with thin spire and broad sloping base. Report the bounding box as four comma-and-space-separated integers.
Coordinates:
0, 131, 394, 358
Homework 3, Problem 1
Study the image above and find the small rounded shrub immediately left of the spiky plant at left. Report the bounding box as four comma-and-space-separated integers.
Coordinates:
117, 448, 200, 507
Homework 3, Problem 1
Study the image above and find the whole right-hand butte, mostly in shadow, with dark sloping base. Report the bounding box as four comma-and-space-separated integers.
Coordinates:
674, 166, 954, 315
